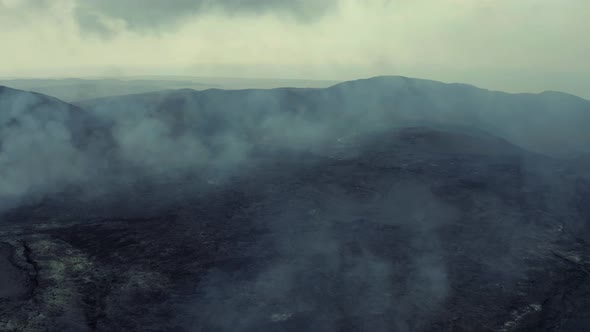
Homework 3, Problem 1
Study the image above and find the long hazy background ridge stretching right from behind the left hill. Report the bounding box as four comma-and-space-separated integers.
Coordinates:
77, 77, 590, 156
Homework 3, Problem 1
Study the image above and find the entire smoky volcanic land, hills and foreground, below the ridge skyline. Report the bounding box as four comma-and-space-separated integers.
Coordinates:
0, 77, 590, 332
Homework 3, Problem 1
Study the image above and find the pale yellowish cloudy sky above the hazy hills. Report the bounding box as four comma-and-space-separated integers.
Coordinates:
0, 0, 590, 98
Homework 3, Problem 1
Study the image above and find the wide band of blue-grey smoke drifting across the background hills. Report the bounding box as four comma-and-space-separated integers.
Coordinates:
0, 77, 590, 213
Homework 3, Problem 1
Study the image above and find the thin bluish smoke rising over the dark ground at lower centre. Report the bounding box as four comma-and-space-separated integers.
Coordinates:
186, 179, 455, 331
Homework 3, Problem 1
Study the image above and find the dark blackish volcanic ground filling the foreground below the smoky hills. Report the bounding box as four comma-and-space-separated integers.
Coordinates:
0, 127, 590, 331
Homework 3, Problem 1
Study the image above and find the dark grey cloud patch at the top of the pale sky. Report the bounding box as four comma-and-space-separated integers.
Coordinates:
74, 0, 338, 36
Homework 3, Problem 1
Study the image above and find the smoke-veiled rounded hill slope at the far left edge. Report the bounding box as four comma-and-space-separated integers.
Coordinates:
0, 86, 112, 210
